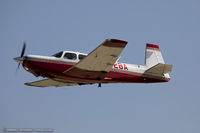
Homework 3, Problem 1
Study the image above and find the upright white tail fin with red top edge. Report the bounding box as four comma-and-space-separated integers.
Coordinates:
145, 43, 165, 68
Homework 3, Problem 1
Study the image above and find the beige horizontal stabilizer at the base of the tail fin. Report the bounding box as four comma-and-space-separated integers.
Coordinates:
145, 63, 172, 74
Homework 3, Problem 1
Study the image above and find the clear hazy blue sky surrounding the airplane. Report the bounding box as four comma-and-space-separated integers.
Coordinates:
0, 0, 200, 133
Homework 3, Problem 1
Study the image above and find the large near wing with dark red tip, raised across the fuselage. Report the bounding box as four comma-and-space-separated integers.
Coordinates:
64, 39, 127, 79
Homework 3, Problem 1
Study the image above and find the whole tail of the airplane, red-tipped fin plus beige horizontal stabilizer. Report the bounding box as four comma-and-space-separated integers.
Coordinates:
145, 43, 172, 77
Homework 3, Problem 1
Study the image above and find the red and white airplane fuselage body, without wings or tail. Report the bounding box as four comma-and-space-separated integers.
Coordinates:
19, 51, 170, 83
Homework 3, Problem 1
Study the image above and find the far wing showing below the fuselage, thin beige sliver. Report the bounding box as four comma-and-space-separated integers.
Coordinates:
25, 79, 81, 87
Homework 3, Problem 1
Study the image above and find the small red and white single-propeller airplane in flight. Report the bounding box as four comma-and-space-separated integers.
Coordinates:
14, 39, 172, 87
